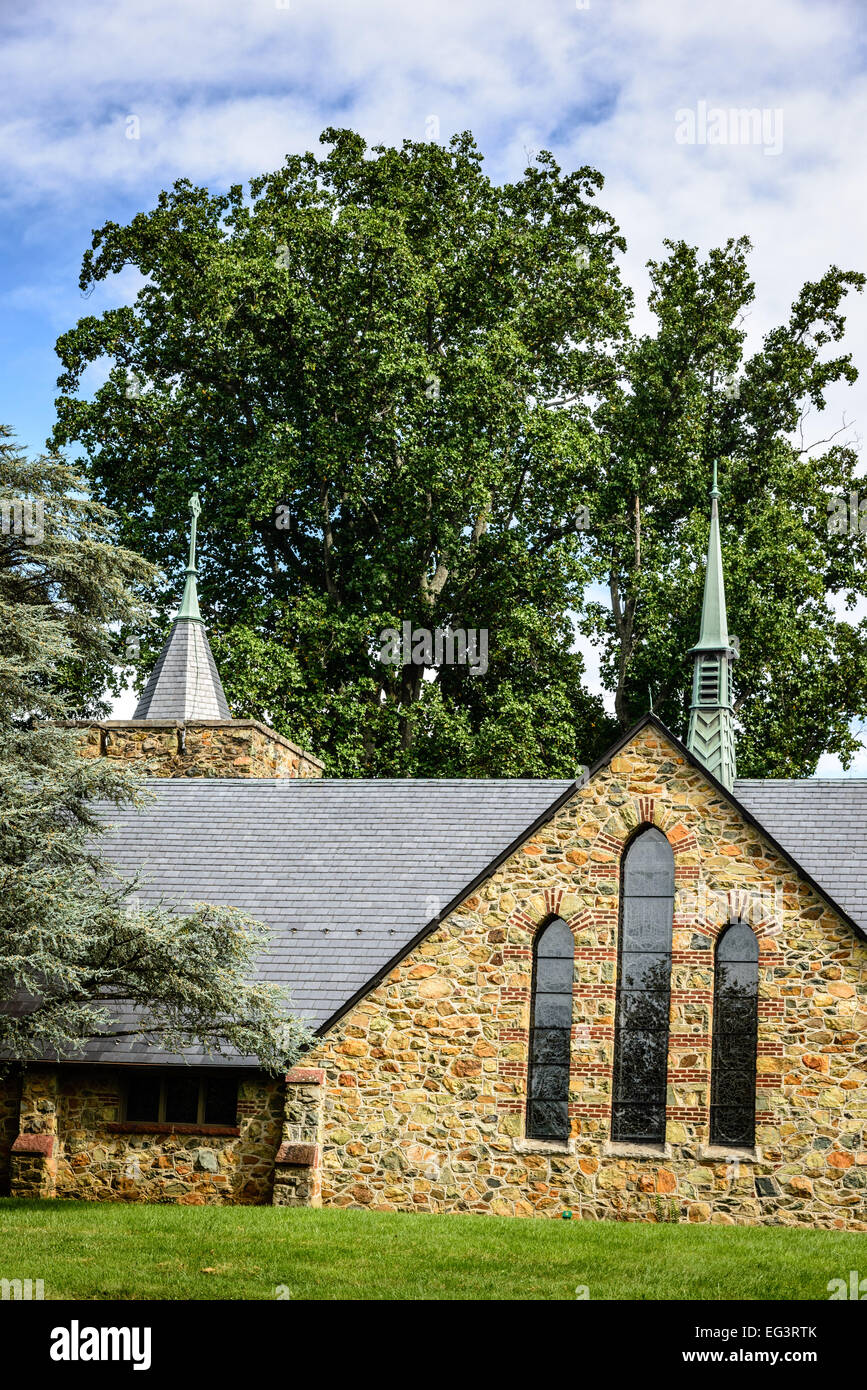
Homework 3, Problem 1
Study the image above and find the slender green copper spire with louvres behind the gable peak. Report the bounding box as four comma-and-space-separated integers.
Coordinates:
686, 463, 736, 791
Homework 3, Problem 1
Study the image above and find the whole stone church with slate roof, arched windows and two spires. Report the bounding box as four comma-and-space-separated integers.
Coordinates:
0, 481, 867, 1230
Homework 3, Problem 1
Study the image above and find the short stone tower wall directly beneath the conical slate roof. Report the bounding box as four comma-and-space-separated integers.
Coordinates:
71, 719, 324, 777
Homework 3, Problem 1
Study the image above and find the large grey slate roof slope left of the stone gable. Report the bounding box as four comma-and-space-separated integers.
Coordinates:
76, 778, 575, 1065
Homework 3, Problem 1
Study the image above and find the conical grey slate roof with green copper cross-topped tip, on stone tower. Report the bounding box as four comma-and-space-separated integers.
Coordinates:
133, 493, 232, 719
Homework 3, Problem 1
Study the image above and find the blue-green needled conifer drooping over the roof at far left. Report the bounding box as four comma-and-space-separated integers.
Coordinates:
0, 427, 308, 1066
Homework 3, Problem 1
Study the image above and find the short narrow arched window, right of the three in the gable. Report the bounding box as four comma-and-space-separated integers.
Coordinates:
710, 922, 759, 1148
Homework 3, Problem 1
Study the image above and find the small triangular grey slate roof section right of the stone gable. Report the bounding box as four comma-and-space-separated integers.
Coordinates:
735, 777, 867, 931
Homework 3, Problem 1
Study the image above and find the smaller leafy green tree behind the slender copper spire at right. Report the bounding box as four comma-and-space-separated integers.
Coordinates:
582, 238, 867, 777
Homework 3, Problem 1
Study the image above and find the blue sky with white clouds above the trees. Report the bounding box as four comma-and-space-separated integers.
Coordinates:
0, 0, 867, 776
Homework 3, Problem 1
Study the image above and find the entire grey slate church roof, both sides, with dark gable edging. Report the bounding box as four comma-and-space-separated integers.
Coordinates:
72, 714, 867, 1066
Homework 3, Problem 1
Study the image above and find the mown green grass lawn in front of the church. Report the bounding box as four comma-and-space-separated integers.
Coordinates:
0, 1200, 867, 1300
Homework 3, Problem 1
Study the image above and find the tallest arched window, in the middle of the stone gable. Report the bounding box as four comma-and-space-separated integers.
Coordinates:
611, 827, 674, 1144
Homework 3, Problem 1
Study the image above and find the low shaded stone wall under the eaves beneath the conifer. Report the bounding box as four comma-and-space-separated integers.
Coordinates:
4, 1066, 283, 1205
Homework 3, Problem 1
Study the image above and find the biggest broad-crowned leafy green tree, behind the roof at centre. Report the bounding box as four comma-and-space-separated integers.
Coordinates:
57, 131, 628, 776
